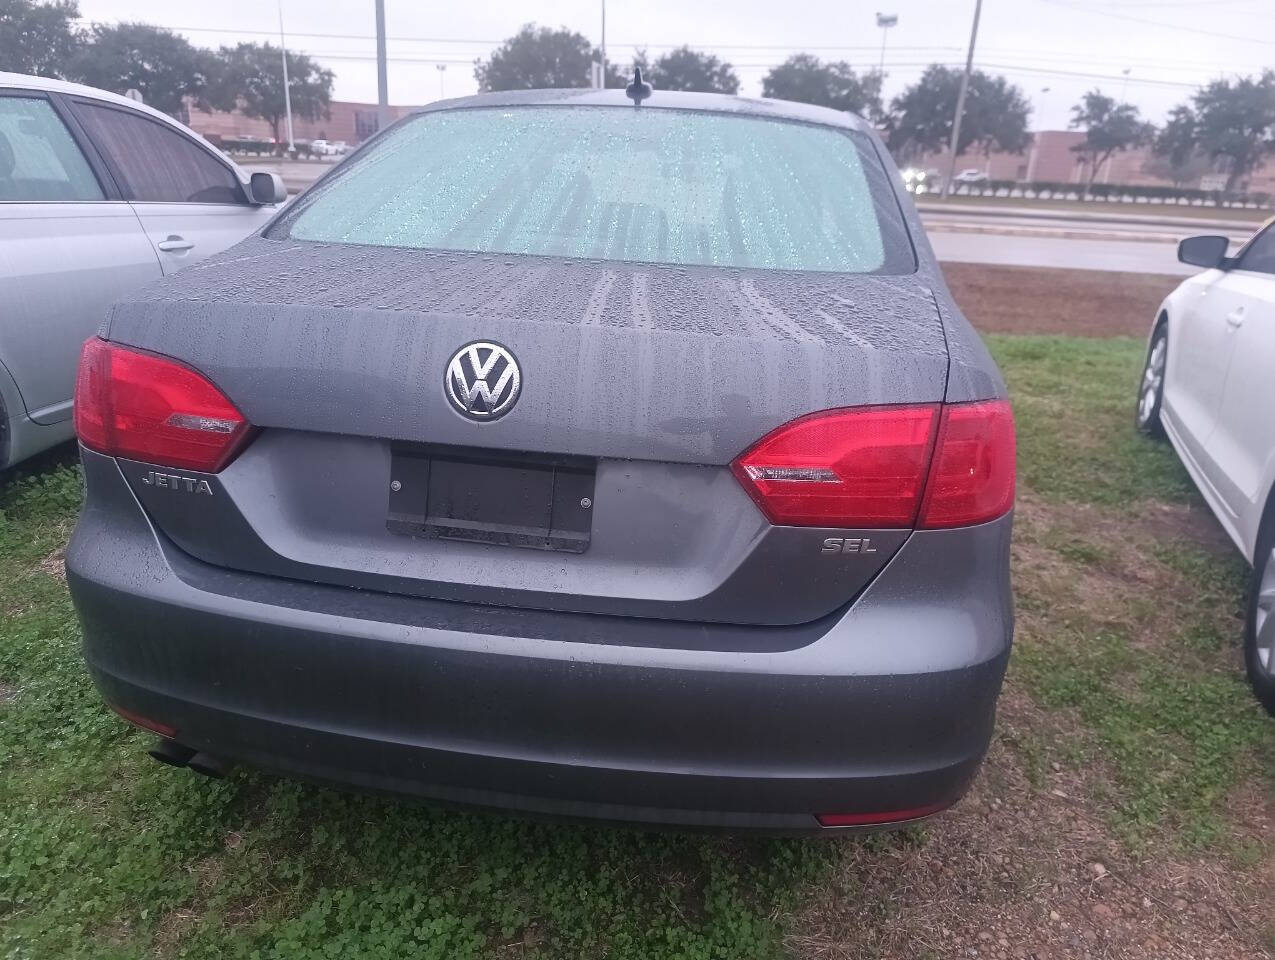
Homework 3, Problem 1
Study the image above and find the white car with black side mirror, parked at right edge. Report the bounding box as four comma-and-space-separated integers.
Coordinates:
1137, 222, 1275, 715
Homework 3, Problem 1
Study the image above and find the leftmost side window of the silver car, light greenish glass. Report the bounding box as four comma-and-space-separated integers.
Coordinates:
0, 97, 105, 203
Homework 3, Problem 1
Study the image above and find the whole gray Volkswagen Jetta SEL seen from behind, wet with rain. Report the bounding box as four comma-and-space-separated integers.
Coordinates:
66, 91, 1015, 830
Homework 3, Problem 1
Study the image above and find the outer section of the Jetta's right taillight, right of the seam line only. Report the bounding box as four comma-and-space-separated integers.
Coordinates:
918, 400, 1016, 529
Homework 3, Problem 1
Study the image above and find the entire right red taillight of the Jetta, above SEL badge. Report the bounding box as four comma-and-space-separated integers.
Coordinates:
732, 400, 1015, 528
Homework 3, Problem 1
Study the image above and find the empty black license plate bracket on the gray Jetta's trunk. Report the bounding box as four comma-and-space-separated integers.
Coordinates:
385, 444, 597, 553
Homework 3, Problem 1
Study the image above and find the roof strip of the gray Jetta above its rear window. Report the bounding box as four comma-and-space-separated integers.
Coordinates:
417, 88, 872, 133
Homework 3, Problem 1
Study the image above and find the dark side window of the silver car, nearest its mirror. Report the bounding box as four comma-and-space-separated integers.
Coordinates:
75, 101, 244, 203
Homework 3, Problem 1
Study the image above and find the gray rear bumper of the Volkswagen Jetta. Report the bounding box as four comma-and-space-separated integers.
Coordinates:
66, 453, 1012, 830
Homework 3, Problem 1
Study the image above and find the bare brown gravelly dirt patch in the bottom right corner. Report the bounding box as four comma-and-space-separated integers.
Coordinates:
788, 687, 1266, 960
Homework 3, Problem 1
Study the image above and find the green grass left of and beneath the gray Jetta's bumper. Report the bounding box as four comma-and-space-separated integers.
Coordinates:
0, 465, 829, 960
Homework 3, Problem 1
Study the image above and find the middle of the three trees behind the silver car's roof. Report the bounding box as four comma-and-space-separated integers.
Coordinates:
70, 23, 218, 116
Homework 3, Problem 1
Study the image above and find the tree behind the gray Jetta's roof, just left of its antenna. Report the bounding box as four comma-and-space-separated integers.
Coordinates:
474, 23, 629, 93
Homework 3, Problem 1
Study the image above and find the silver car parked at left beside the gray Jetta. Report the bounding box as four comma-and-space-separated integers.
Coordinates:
0, 73, 287, 469
